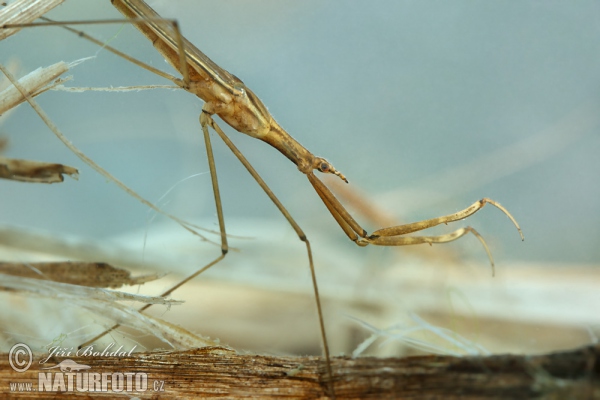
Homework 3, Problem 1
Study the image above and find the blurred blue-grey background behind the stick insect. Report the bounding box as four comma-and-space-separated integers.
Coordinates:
0, 0, 600, 264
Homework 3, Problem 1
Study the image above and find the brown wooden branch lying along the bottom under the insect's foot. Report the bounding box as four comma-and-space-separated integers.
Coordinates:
0, 345, 600, 399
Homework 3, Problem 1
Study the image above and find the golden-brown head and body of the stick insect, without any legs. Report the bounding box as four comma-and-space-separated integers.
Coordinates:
112, 0, 345, 180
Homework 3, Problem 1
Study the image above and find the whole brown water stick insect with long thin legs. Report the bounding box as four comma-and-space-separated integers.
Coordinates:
2, 0, 522, 394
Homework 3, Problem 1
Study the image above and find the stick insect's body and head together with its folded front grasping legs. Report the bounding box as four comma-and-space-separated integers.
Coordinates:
111, 0, 522, 248
